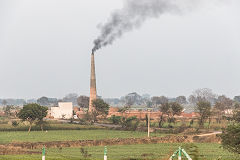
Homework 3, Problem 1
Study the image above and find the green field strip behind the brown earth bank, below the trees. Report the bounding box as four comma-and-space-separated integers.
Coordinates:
0, 129, 166, 144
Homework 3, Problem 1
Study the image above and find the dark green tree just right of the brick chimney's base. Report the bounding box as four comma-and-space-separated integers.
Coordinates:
92, 99, 109, 121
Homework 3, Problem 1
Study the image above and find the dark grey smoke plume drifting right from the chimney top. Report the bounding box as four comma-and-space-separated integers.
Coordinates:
93, 0, 220, 52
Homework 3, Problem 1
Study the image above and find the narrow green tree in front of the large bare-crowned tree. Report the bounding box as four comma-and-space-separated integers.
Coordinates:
196, 101, 211, 126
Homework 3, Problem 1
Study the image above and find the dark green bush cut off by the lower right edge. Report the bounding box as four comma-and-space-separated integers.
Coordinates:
220, 124, 240, 154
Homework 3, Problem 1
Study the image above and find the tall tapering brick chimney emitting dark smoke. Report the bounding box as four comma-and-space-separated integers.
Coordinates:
88, 53, 97, 112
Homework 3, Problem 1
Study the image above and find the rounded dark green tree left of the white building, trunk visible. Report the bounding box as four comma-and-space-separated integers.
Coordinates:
17, 103, 48, 133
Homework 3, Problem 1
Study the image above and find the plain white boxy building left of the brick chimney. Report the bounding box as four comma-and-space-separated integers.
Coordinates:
51, 102, 73, 119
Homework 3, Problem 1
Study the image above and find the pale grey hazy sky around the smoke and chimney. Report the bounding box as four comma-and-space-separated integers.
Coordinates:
0, 0, 240, 98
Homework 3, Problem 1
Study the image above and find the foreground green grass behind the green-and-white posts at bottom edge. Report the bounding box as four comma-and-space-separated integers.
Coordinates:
0, 143, 240, 160
